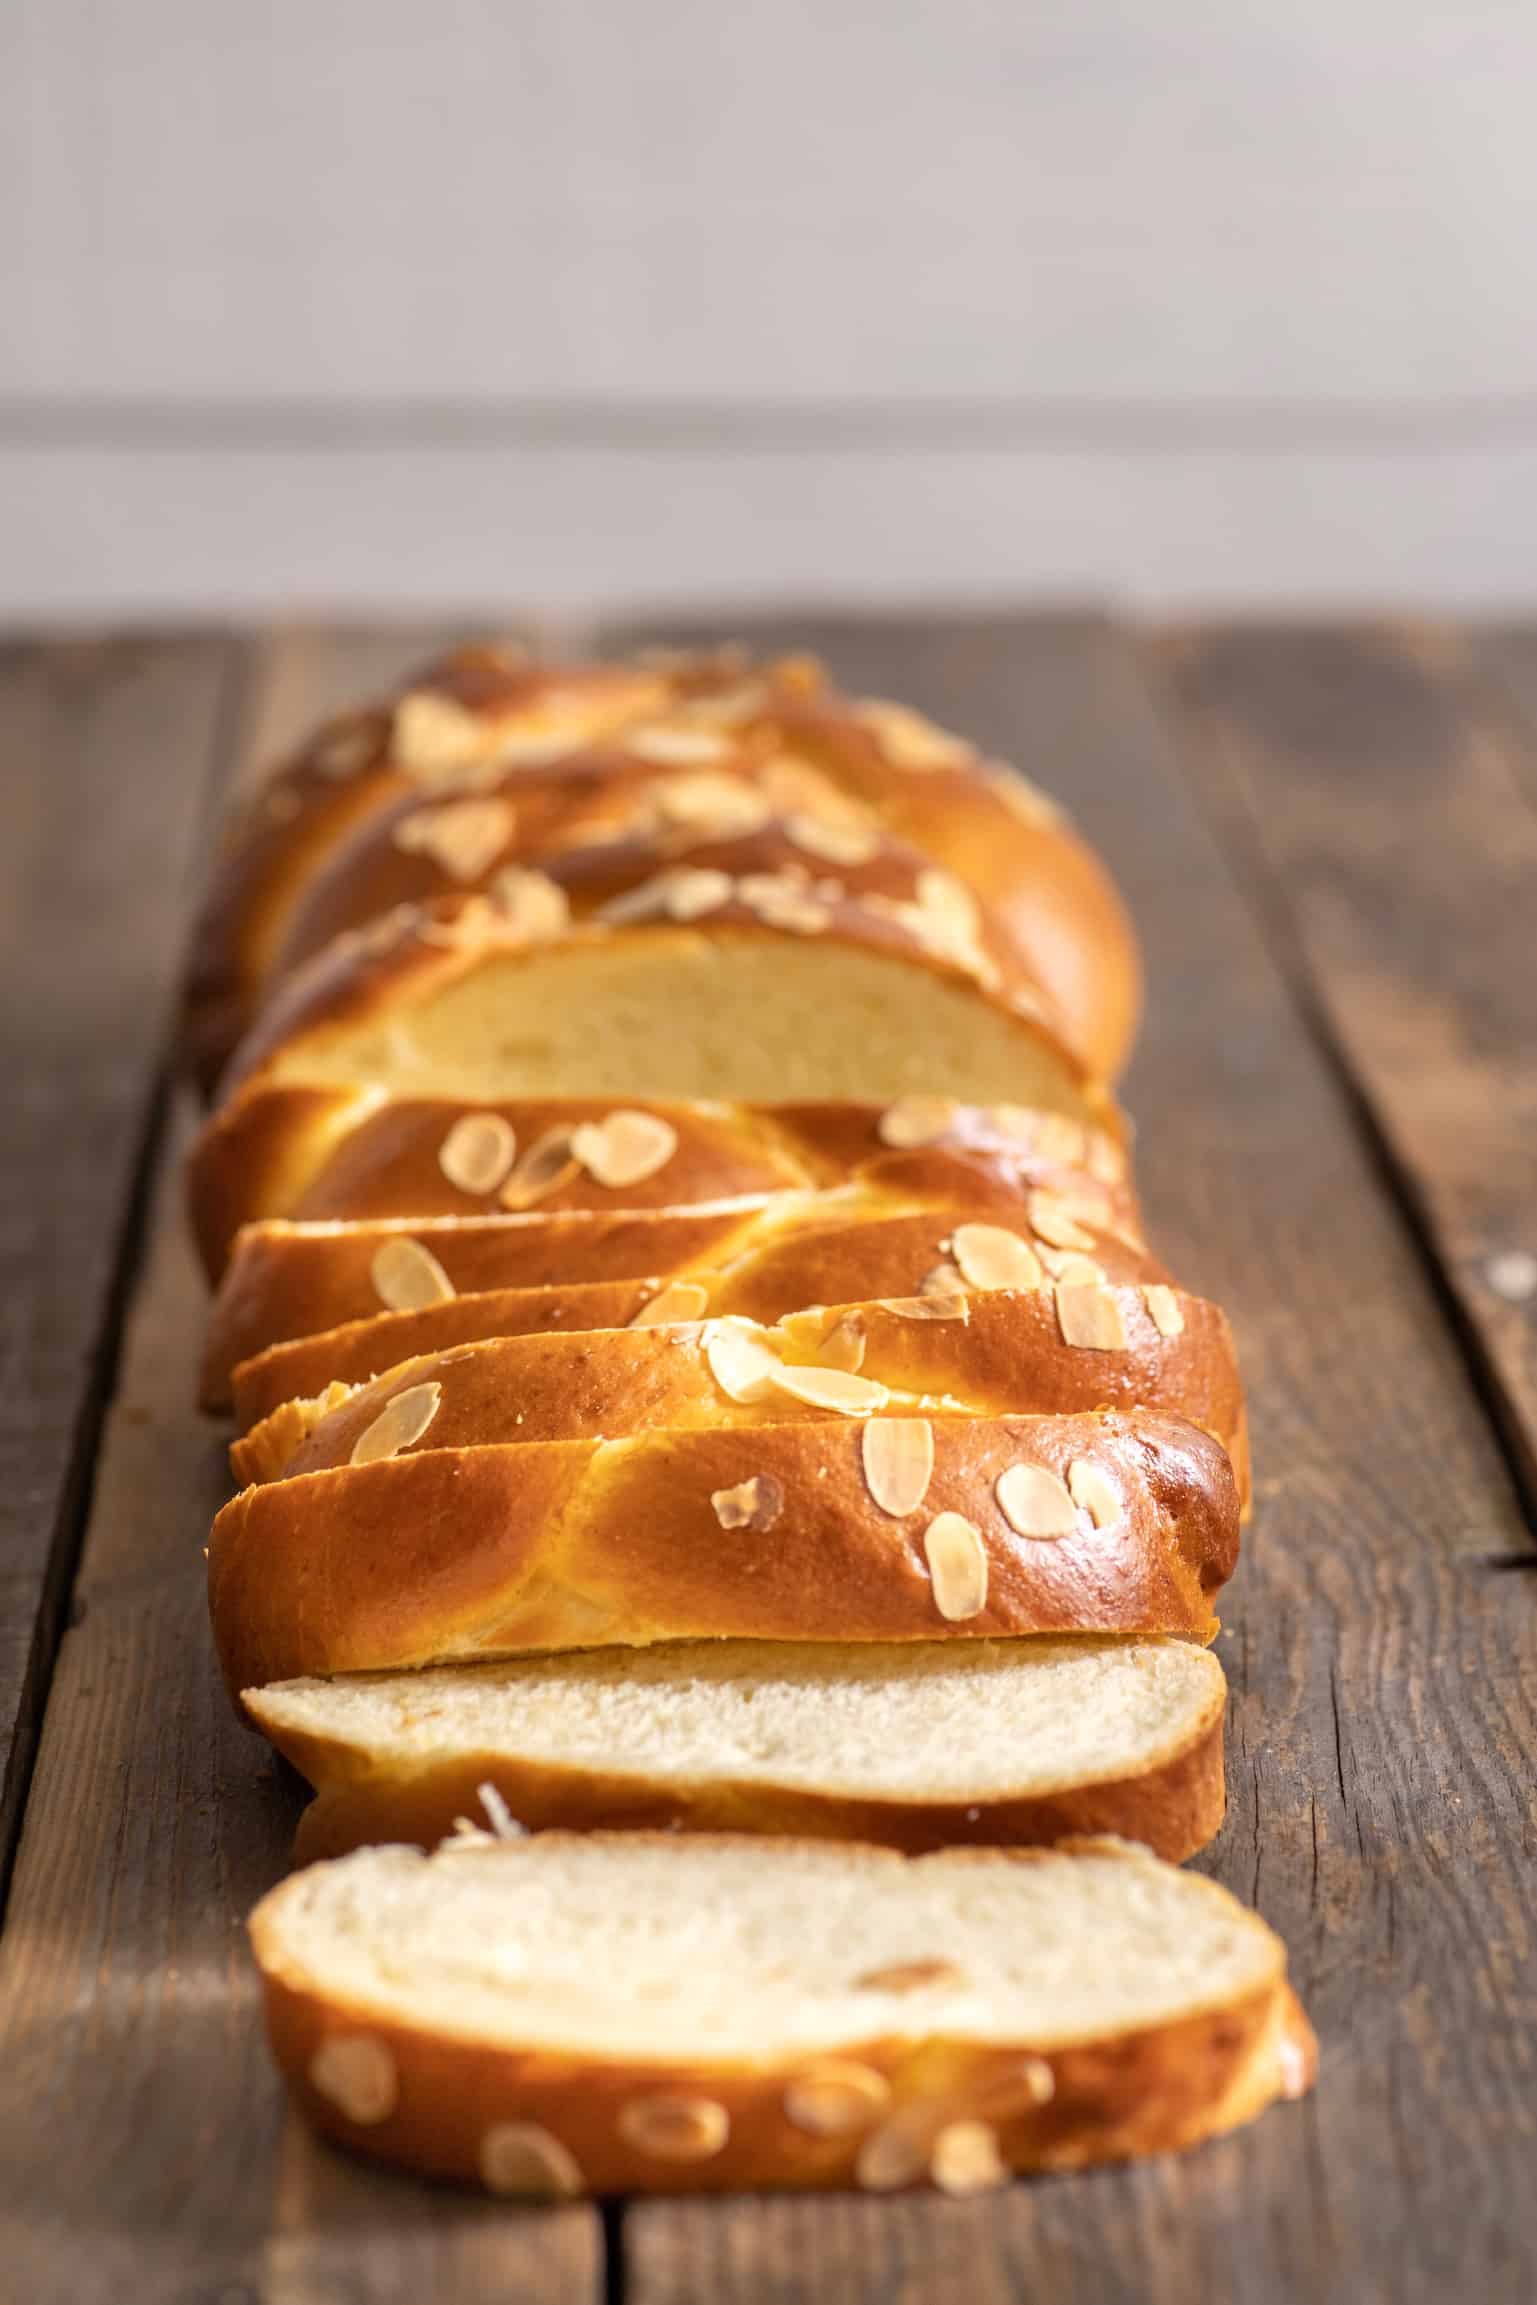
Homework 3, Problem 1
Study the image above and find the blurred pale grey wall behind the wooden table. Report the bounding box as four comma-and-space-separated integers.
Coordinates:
0, 0, 1537, 620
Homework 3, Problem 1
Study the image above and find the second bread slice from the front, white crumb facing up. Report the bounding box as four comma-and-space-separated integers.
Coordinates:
247, 1641, 1226, 1860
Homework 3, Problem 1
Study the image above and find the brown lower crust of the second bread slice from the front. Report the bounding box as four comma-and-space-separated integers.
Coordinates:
258, 1690, 1226, 1865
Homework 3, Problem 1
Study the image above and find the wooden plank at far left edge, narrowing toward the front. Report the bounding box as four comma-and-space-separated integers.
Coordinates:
0, 636, 233, 1885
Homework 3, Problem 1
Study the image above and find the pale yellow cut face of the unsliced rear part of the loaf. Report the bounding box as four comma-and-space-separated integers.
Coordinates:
230, 906, 1106, 1120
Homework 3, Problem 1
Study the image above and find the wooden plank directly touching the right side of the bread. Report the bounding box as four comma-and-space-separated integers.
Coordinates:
603, 620, 1537, 2305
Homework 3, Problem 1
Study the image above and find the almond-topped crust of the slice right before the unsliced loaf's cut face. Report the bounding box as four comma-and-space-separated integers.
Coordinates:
187, 1081, 1141, 1290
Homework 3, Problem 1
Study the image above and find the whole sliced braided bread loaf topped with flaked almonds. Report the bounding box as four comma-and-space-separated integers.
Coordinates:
189, 650, 1311, 2192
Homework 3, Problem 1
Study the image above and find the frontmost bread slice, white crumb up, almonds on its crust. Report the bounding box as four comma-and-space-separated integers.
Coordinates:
251, 1832, 1313, 2197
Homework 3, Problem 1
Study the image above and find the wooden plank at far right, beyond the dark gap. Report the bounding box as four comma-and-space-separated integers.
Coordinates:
1157, 625, 1537, 1507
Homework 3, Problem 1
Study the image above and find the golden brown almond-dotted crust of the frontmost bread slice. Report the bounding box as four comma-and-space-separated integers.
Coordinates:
251, 1851, 1316, 2194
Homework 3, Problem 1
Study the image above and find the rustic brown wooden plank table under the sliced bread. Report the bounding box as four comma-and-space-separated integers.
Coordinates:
0, 618, 1537, 2305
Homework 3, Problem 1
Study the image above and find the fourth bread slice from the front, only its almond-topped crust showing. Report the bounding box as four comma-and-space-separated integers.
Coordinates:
230, 1290, 1247, 1501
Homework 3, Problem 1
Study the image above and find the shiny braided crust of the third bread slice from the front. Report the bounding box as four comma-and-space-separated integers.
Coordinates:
210, 1413, 1237, 1692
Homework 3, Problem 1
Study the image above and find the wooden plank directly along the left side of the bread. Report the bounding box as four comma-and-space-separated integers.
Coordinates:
0, 634, 601, 2305
